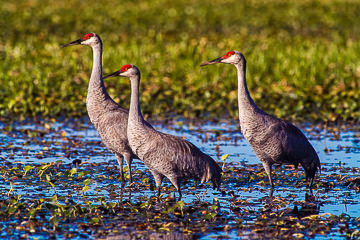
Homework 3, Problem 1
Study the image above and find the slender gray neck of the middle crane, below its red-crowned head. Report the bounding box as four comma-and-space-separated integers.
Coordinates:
129, 73, 144, 123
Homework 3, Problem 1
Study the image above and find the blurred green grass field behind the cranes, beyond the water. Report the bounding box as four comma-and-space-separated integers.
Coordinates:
0, 0, 360, 121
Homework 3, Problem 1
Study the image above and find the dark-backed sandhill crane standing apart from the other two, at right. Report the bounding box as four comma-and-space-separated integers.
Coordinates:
200, 51, 320, 189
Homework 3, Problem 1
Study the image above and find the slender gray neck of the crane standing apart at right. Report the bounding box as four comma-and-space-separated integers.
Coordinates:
235, 61, 258, 115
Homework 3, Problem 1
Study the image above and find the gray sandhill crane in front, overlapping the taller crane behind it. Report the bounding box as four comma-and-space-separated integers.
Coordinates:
104, 64, 222, 199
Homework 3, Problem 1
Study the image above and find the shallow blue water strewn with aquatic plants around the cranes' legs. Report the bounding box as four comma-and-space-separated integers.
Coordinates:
0, 119, 360, 239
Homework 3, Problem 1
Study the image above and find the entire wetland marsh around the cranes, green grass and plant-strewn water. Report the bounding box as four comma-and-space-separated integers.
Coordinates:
0, 0, 360, 239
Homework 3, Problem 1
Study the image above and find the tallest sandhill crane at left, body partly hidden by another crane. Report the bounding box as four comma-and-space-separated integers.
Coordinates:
62, 33, 137, 183
